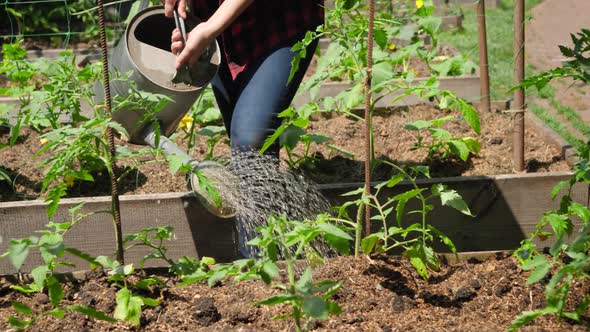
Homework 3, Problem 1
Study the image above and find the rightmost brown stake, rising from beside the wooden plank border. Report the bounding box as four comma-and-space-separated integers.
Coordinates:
512, 0, 526, 172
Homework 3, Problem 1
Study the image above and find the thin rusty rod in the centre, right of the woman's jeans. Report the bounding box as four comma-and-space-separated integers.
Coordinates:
365, 0, 375, 236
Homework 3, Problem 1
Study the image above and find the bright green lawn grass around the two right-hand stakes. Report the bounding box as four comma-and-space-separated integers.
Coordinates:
440, 0, 542, 99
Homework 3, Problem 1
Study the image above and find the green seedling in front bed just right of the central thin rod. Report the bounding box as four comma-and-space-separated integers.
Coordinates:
332, 163, 472, 279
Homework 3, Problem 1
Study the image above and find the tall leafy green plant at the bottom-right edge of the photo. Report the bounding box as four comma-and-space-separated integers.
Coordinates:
509, 142, 590, 331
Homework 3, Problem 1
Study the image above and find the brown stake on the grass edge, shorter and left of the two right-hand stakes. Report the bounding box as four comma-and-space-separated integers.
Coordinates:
477, 0, 492, 112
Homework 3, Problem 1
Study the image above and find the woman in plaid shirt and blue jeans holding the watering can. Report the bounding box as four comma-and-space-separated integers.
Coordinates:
162, 0, 324, 155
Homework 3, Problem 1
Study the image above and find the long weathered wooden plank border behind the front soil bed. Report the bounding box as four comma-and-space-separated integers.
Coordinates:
0, 172, 588, 274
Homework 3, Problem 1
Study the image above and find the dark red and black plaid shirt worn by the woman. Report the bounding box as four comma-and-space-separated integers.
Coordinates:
192, 0, 324, 79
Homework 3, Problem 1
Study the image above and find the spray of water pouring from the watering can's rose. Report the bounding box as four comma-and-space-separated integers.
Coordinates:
207, 152, 330, 257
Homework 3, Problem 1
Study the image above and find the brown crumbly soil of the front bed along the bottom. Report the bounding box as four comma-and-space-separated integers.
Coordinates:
0, 255, 590, 332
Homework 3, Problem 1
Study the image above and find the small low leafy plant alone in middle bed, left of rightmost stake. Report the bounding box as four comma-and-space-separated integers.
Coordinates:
404, 116, 481, 161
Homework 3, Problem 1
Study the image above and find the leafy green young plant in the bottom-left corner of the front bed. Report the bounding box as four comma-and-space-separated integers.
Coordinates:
1, 204, 114, 330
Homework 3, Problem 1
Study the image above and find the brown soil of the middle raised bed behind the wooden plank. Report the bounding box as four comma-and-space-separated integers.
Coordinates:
0, 105, 570, 201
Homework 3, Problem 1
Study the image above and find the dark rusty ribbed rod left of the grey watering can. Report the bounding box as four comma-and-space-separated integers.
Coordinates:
98, 0, 125, 264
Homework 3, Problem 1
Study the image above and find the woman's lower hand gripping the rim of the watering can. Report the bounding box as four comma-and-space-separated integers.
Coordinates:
170, 22, 215, 69
